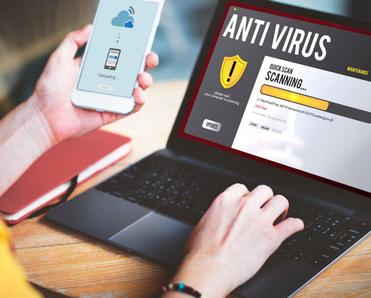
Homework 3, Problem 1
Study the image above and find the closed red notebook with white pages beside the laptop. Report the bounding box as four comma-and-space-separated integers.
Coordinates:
0, 130, 131, 224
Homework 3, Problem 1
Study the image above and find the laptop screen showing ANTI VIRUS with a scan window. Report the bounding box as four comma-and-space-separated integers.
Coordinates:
181, 2, 371, 193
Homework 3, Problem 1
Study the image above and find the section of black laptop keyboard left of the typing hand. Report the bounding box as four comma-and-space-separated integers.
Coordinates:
98, 155, 241, 225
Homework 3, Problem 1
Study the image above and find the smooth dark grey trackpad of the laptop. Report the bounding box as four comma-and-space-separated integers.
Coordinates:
109, 212, 192, 266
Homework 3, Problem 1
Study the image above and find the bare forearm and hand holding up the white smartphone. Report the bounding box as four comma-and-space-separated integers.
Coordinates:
0, 25, 158, 196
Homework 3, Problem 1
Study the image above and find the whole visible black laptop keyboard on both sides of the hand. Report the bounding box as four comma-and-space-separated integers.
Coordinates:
97, 155, 370, 268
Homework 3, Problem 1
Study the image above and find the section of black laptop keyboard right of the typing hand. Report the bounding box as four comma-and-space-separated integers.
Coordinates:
275, 201, 370, 267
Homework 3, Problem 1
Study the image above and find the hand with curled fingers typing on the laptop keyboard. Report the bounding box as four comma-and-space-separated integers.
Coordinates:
169, 184, 304, 298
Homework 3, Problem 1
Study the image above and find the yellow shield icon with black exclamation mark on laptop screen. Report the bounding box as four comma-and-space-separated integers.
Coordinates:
220, 55, 248, 89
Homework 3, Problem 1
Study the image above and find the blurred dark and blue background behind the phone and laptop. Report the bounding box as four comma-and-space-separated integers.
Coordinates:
0, 0, 371, 119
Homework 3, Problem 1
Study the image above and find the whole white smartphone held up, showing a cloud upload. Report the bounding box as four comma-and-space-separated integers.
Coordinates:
72, 0, 165, 114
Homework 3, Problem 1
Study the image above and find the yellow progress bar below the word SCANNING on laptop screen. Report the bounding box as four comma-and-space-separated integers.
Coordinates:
260, 85, 330, 111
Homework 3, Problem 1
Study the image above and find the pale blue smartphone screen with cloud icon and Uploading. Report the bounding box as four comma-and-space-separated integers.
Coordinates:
77, 0, 160, 98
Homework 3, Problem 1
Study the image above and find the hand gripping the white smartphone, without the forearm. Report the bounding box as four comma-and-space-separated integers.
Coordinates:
30, 25, 159, 145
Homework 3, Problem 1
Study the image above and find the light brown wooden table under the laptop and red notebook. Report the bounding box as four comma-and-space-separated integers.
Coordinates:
12, 82, 371, 298
